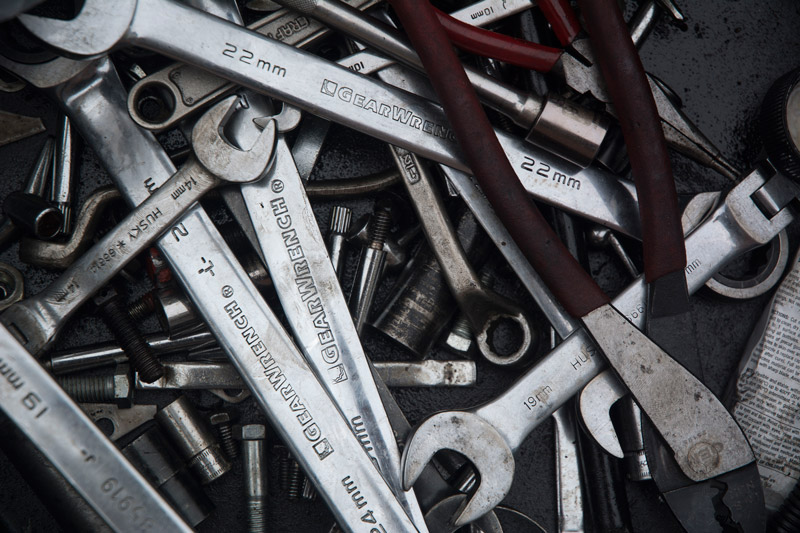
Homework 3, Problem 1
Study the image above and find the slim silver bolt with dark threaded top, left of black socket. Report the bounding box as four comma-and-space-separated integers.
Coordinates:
350, 207, 392, 333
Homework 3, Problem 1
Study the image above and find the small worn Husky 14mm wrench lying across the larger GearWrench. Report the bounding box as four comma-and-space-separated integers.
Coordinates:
0, 97, 275, 354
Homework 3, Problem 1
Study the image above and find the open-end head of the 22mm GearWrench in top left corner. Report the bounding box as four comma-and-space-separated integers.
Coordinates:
19, 0, 137, 57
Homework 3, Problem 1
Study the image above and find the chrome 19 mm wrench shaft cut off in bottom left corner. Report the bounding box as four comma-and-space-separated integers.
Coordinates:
0, 326, 192, 532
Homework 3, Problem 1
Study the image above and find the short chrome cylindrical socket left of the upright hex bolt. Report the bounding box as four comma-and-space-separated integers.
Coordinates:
155, 396, 231, 484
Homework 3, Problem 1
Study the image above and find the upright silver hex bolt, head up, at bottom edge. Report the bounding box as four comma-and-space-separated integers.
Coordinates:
238, 424, 267, 533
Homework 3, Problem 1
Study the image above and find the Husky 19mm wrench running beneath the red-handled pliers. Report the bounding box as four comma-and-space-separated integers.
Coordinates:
403, 165, 797, 530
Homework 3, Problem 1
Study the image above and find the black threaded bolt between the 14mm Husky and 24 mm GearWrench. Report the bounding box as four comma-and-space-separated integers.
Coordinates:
94, 287, 164, 383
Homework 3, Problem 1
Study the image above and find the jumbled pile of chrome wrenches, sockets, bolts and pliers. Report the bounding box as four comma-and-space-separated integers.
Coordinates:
0, 0, 800, 533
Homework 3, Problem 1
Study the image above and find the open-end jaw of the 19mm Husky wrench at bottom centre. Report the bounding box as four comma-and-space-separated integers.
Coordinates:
400, 411, 514, 527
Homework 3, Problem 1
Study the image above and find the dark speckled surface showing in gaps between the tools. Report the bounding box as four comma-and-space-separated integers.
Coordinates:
0, 0, 800, 533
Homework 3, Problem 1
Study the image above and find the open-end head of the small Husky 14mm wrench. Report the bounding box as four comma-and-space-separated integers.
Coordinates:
192, 95, 277, 183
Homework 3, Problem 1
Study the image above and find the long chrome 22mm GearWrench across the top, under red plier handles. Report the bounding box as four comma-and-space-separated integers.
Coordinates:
20, 0, 639, 236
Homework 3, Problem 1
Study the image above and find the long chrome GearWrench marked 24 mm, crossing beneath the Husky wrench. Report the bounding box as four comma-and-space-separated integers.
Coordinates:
0, 55, 422, 532
